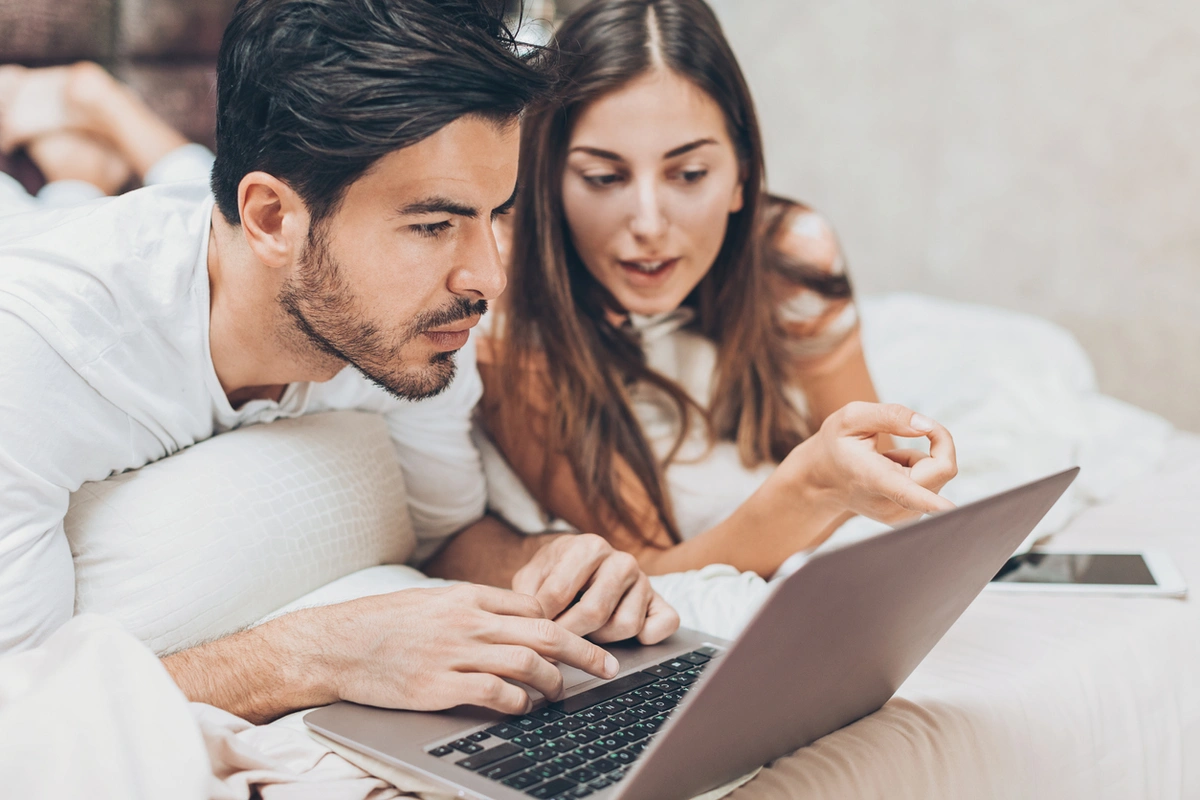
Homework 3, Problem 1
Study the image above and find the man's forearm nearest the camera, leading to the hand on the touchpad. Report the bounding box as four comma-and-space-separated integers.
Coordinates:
162, 608, 338, 723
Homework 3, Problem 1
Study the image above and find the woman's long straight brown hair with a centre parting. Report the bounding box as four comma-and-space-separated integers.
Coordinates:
493, 0, 817, 542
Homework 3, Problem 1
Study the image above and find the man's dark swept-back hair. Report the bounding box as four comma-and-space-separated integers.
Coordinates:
212, 0, 550, 224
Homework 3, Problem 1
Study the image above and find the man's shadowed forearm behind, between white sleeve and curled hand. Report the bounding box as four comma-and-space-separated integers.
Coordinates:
424, 515, 570, 589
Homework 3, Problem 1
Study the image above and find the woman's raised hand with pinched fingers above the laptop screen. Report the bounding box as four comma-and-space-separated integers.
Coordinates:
772, 403, 958, 525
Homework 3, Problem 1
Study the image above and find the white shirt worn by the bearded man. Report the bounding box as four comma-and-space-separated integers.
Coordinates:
0, 182, 486, 654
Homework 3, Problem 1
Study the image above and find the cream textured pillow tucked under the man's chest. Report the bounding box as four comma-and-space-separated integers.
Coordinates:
66, 411, 415, 654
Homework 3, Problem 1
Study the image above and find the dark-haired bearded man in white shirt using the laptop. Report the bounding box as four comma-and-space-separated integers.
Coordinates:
0, 0, 678, 721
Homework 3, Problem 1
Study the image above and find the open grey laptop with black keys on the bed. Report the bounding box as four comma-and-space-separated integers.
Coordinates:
305, 468, 1079, 800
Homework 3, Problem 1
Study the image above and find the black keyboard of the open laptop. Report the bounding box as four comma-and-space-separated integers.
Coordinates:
428, 646, 720, 800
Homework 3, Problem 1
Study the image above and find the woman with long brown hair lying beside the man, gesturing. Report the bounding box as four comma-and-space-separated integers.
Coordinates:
480, 0, 955, 576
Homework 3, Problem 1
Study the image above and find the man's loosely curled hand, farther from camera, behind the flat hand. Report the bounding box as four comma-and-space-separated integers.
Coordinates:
512, 534, 679, 644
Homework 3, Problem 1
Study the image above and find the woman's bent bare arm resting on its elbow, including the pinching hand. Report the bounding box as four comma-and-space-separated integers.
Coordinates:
479, 355, 953, 577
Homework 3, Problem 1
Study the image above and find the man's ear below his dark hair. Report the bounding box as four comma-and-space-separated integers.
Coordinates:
238, 172, 310, 269
